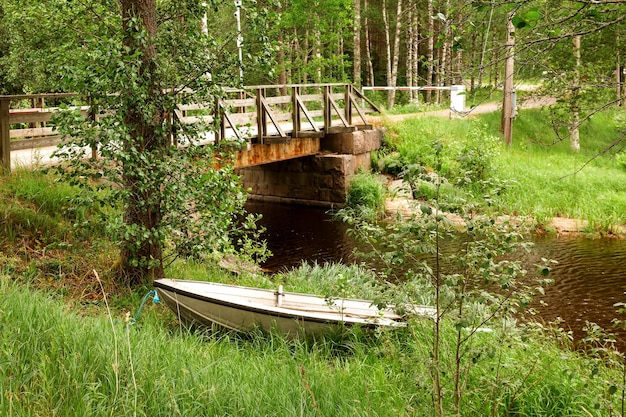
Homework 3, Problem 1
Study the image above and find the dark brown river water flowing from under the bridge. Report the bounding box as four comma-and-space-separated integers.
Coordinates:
247, 202, 626, 344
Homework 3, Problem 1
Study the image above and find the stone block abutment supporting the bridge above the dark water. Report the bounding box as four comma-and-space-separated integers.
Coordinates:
237, 129, 383, 207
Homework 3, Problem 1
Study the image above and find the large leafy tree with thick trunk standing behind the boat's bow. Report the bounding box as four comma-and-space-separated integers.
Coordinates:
45, 0, 264, 285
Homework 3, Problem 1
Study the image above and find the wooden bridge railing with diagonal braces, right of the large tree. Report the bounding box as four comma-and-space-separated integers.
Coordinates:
174, 84, 380, 144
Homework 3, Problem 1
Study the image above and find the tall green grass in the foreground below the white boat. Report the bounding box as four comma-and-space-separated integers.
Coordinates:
0, 277, 616, 417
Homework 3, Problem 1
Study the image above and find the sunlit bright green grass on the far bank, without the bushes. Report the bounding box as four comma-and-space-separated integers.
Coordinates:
388, 104, 626, 230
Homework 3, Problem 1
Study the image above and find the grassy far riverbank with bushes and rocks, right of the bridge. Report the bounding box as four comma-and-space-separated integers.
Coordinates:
374, 101, 626, 237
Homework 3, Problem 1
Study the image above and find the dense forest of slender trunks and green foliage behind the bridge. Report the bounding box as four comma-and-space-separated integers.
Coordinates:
0, 0, 626, 107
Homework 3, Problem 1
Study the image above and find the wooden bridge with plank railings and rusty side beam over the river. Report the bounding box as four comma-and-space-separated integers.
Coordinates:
0, 84, 379, 173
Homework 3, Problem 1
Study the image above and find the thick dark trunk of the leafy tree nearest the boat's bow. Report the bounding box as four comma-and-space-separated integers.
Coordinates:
120, 0, 167, 283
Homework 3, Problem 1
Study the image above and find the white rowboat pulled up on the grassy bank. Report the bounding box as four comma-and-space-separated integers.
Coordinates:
154, 279, 431, 336
